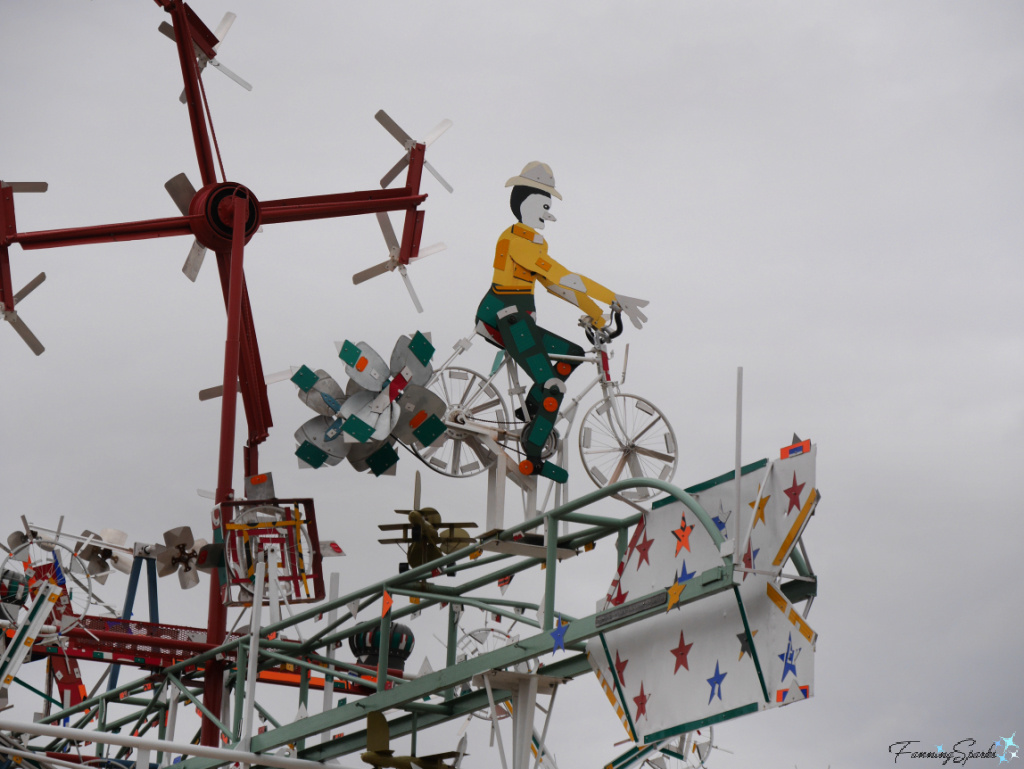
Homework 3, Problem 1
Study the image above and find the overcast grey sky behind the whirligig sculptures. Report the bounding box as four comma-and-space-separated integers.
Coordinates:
0, 0, 1024, 769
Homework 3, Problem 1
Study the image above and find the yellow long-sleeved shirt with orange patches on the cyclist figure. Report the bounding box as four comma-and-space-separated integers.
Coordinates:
494, 224, 615, 328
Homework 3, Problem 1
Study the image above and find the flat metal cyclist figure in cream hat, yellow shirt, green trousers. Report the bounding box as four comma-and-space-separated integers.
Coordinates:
476, 161, 647, 483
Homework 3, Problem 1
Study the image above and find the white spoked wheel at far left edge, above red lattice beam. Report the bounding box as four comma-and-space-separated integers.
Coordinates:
0, 537, 93, 644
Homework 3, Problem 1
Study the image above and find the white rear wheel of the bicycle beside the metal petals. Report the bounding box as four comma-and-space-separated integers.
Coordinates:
414, 366, 511, 478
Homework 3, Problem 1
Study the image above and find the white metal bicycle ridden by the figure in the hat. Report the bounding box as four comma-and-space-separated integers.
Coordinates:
415, 312, 679, 510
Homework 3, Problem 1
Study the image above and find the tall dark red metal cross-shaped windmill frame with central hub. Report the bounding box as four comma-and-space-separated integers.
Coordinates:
0, 0, 427, 745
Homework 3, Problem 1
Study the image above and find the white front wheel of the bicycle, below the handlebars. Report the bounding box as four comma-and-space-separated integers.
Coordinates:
580, 393, 679, 500
